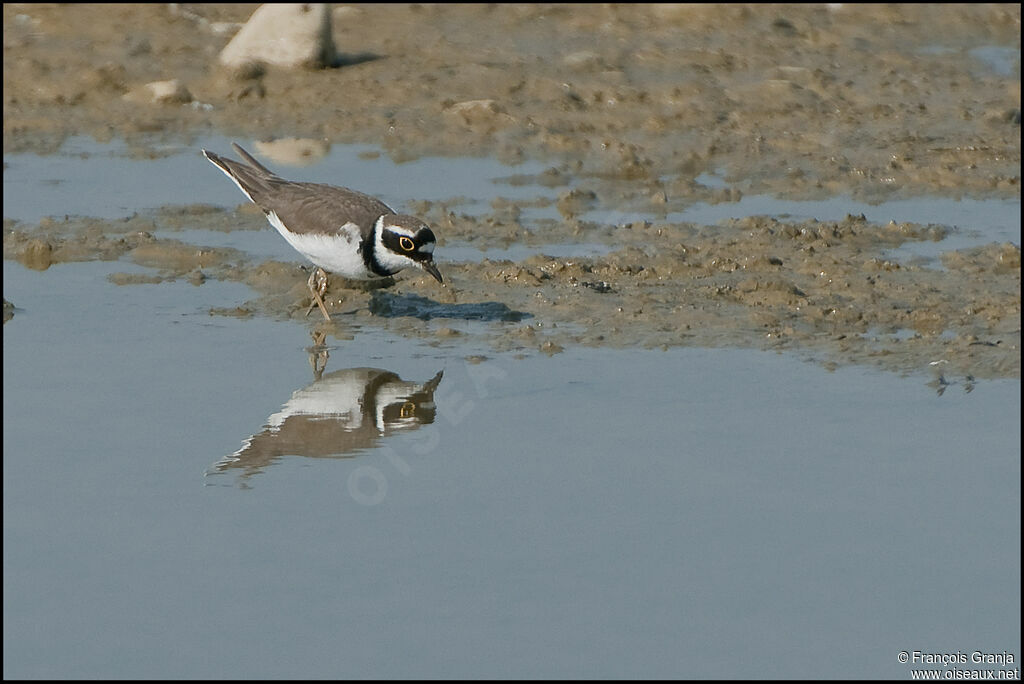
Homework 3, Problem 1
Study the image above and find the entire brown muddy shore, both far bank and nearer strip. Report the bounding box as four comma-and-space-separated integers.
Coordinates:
4, 4, 1020, 378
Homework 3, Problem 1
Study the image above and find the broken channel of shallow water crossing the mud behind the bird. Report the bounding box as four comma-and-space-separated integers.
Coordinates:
4, 136, 1021, 267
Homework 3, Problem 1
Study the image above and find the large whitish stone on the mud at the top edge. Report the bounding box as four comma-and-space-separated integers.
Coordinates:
220, 3, 337, 69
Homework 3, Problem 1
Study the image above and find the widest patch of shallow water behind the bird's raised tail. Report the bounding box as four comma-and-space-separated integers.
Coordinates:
4, 136, 553, 221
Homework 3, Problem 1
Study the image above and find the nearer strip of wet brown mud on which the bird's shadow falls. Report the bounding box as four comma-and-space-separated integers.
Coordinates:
4, 205, 1020, 378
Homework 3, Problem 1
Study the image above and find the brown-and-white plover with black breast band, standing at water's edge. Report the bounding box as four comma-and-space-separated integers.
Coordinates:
203, 142, 443, 320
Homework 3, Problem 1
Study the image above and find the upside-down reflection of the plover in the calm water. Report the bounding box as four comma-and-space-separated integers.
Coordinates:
208, 334, 444, 486
